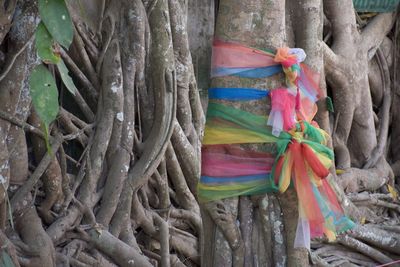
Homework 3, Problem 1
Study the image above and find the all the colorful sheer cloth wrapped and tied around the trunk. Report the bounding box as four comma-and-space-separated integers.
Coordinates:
198, 41, 354, 248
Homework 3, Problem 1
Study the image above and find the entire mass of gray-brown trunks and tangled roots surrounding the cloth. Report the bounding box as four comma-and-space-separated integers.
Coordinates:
0, 0, 400, 267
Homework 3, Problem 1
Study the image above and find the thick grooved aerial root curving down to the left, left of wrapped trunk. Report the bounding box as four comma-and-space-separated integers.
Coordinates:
128, 1, 177, 190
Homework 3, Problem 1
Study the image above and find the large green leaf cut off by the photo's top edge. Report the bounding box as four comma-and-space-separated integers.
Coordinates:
39, 0, 74, 49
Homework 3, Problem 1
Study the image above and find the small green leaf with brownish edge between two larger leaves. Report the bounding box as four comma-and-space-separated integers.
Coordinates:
36, 22, 60, 64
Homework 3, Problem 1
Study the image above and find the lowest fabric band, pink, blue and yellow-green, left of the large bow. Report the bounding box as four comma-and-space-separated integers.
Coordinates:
198, 145, 274, 201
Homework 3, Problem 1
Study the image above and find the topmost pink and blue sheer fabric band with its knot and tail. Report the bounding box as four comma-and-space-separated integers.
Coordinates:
211, 40, 320, 102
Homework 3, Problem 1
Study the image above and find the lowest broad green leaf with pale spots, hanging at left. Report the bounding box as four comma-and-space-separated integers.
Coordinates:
29, 65, 59, 126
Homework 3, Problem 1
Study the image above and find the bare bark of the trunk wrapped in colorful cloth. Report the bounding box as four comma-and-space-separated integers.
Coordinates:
202, 1, 310, 266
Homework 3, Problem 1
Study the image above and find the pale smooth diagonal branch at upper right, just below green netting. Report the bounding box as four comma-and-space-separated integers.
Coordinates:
361, 13, 396, 59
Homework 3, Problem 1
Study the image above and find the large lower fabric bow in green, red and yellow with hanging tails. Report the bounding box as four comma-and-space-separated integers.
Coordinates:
272, 122, 340, 244
